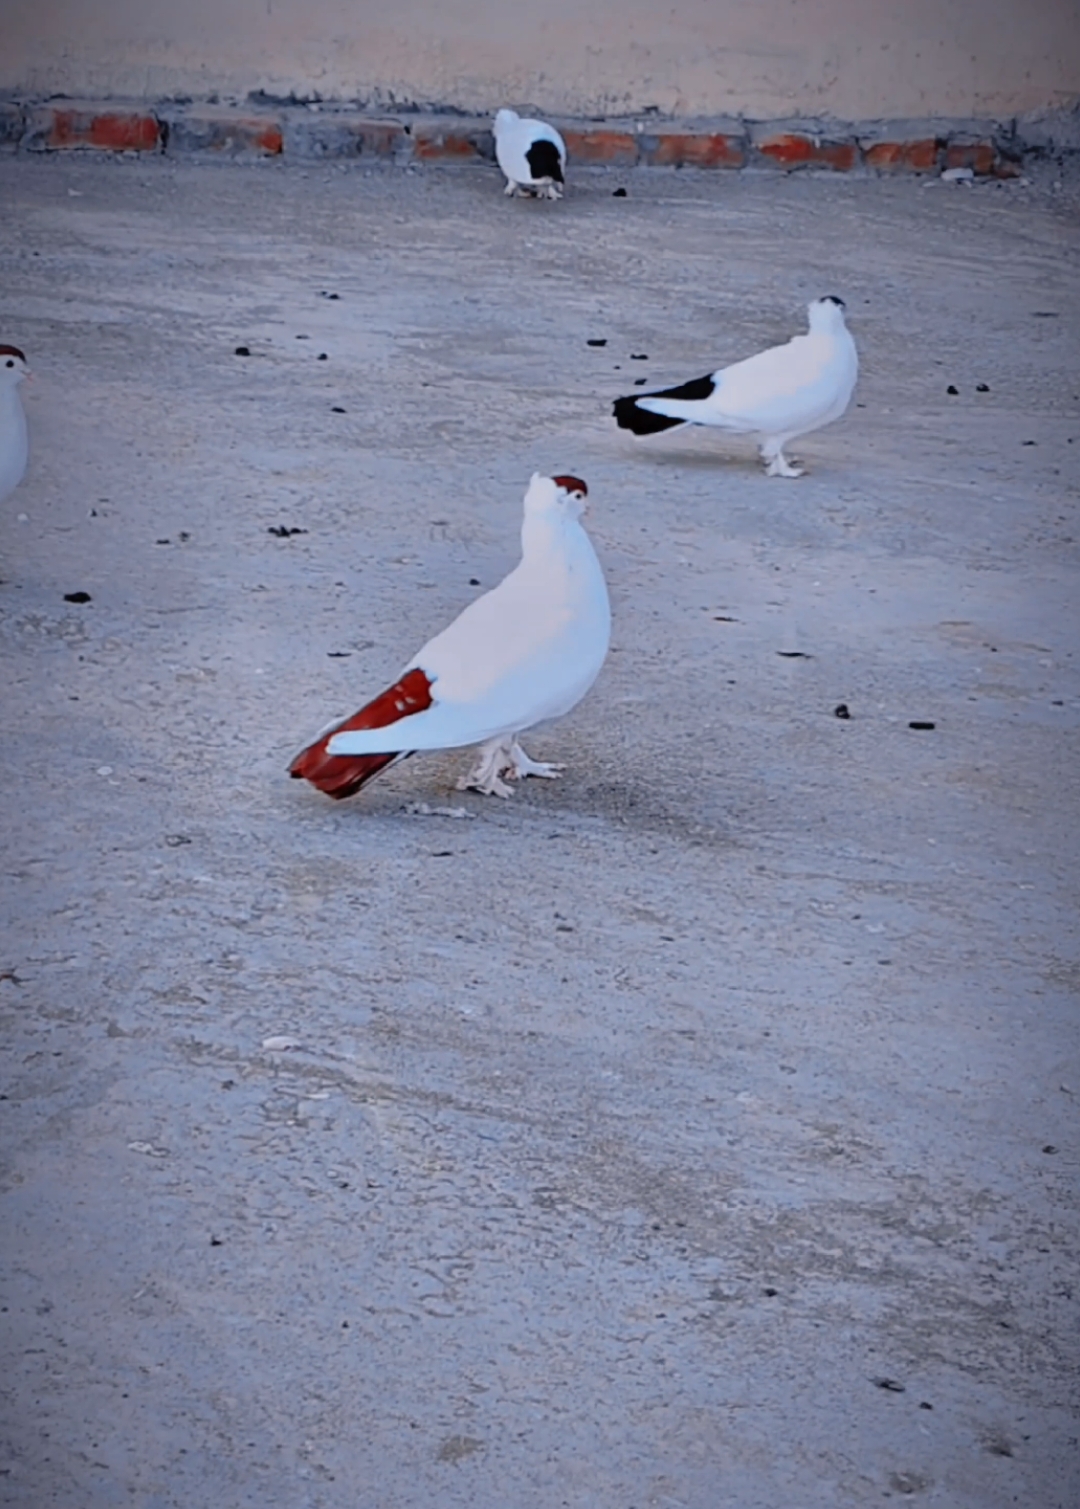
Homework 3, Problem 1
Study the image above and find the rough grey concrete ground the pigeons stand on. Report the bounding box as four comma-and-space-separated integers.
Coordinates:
0, 157, 1080, 1509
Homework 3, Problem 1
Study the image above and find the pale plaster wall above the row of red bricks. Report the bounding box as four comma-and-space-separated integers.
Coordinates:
0, 0, 1080, 121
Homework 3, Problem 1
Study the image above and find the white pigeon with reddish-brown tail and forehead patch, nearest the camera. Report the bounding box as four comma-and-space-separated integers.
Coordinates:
290, 472, 611, 797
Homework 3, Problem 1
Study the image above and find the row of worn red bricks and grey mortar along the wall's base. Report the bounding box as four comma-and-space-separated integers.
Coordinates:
0, 100, 1045, 178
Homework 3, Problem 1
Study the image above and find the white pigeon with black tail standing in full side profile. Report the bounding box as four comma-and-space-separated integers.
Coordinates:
615, 294, 858, 477
